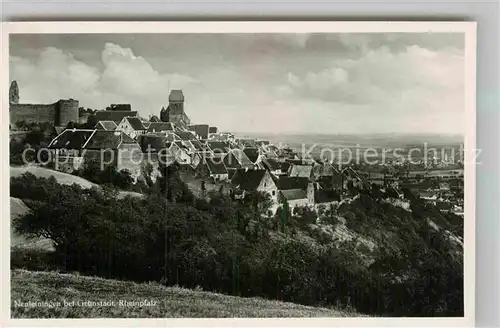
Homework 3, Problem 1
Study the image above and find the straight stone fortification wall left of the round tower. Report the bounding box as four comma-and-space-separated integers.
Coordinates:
9, 103, 57, 125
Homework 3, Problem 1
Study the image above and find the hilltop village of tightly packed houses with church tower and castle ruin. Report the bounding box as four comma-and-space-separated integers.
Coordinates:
10, 82, 464, 216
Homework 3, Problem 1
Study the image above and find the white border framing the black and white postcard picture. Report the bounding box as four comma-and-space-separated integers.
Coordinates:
0, 21, 476, 327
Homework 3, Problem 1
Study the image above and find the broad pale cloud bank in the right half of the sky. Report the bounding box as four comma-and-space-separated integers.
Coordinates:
286, 46, 464, 104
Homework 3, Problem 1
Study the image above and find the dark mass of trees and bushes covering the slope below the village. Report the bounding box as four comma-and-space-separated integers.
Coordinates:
11, 168, 463, 316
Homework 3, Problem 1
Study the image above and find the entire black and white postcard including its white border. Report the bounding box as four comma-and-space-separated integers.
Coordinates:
3, 22, 481, 320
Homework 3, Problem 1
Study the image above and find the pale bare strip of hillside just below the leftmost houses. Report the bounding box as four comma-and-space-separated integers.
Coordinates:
10, 166, 142, 198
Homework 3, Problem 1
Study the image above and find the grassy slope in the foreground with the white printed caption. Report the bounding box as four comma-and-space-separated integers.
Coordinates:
11, 270, 358, 318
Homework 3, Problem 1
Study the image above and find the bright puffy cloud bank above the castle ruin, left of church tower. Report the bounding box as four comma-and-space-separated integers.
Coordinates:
11, 43, 198, 117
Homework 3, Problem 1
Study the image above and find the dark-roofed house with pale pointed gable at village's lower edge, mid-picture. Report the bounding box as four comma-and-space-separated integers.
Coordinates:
231, 169, 278, 202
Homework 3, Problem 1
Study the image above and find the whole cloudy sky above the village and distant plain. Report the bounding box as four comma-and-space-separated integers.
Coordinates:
9, 33, 465, 134
